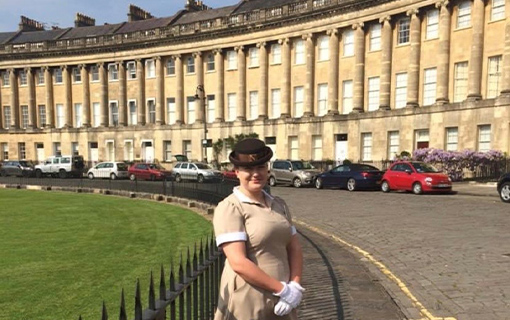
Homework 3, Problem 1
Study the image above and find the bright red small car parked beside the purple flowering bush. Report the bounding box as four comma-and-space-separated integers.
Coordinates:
381, 161, 452, 194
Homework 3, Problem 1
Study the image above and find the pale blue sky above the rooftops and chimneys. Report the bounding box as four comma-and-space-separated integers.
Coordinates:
0, 0, 240, 32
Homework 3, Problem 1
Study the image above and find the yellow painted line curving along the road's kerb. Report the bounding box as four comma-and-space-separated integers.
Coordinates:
293, 219, 457, 320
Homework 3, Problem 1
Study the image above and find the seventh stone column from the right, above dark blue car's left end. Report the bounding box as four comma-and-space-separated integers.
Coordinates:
327, 28, 340, 115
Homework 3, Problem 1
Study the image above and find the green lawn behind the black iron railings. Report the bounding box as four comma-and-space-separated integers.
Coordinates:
0, 189, 212, 320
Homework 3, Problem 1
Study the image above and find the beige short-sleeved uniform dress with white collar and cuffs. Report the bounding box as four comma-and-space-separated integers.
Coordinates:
213, 188, 297, 320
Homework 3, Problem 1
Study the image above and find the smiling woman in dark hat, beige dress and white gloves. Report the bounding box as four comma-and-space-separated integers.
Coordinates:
213, 138, 304, 320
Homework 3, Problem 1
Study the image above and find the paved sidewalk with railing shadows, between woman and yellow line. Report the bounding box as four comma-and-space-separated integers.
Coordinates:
298, 226, 406, 320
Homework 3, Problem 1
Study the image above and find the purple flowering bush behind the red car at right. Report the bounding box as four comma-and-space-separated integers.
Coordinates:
413, 148, 505, 181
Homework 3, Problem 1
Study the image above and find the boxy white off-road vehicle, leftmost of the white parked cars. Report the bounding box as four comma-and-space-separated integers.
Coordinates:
34, 155, 85, 178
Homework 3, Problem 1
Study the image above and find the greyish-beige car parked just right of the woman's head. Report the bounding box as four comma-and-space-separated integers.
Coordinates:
269, 160, 320, 188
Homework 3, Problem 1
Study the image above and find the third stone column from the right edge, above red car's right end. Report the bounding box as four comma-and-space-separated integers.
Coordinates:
436, 0, 451, 105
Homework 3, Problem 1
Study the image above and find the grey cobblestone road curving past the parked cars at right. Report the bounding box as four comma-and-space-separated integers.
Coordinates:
271, 185, 510, 320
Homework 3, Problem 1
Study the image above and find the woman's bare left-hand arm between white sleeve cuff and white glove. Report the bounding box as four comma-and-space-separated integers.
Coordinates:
221, 241, 283, 293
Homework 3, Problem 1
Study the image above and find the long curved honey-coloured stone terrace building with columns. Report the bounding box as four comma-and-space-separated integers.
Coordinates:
0, 0, 510, 162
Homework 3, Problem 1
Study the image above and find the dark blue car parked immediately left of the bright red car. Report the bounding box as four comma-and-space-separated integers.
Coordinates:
315, 163, 383, 191
